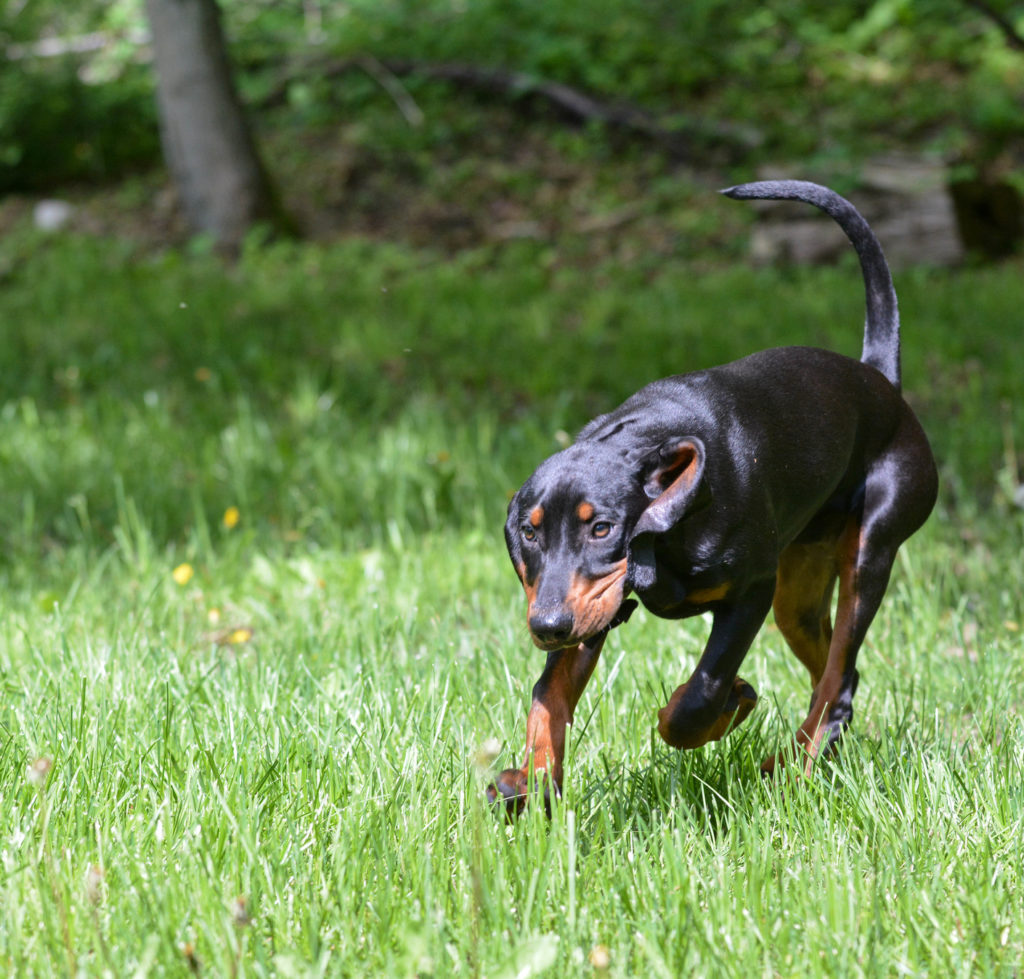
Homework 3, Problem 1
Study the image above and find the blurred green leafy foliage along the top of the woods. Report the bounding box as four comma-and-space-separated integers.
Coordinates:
0, 0, 1024, 190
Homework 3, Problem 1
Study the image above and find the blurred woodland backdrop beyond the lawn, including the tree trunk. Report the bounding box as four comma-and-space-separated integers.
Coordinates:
0, 0, 1024, 261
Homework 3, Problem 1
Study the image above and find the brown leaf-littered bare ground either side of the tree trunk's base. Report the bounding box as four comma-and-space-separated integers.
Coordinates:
0, 107, 744, 262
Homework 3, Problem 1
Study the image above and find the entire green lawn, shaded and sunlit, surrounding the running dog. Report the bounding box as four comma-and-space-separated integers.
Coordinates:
0, 225, 1024, 977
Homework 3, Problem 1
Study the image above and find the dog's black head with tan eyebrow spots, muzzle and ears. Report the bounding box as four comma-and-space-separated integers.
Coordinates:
505, 437, 705, 650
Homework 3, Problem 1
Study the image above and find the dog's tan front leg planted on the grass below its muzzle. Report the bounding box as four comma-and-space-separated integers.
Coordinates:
487, 632, 607, 816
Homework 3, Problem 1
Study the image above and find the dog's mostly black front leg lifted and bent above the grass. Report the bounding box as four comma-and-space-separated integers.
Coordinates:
657, 582, 775, 749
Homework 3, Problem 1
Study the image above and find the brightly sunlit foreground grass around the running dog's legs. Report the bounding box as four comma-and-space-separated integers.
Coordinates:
0, 516, 1024, 976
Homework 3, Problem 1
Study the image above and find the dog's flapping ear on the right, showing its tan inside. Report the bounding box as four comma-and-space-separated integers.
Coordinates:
629, 436, 711, 591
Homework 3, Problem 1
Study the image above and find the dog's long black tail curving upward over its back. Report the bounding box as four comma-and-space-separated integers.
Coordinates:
722, 180, 900, 389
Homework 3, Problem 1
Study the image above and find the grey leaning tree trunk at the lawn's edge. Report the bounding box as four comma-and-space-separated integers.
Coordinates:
145, 0, 287, 251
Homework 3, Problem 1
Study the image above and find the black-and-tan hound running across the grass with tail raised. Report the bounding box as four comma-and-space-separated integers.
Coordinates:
487, 180, 938, 816
